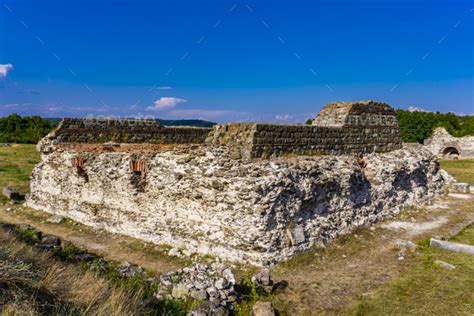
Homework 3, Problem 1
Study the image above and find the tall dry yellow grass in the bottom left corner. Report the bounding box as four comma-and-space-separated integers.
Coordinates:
0, 231, 142, 315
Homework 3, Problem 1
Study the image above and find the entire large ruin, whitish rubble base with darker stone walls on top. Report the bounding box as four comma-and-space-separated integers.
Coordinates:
27, 101, 449, 265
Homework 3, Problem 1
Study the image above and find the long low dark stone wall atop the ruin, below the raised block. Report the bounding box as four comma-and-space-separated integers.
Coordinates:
207, 123, 401, 158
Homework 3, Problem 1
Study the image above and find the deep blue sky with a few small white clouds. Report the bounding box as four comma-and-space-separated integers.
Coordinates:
0, 0, 474, 123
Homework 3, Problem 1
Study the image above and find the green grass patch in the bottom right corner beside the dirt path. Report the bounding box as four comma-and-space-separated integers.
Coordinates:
346, 225, 474, 315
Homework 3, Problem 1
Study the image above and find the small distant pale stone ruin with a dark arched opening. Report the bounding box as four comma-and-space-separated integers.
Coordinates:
424, 127, 474, 160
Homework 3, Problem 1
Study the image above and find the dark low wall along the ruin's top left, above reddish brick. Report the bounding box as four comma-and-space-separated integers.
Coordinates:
50, 118, 211, 144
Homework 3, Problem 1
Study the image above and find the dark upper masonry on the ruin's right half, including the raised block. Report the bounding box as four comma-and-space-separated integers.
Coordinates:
206, 101, 402, 159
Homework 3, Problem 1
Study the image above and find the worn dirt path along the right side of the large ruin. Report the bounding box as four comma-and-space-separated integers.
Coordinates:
274, 194, 474, 315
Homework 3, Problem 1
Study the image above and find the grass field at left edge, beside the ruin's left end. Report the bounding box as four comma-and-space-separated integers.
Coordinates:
0, 144, 40, 194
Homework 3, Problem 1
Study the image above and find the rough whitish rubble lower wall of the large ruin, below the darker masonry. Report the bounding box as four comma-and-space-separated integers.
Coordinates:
27, 146, 448, 264
